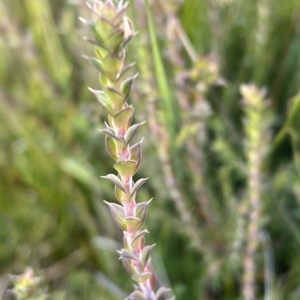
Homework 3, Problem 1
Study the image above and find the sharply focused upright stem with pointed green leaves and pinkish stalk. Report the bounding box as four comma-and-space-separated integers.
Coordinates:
81, 0, 173, 300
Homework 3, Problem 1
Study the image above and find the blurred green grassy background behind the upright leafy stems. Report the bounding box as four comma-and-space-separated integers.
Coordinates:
0, 0, 300, 300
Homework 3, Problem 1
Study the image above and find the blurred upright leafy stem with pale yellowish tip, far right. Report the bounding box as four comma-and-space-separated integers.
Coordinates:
240, 85, 268, 300
